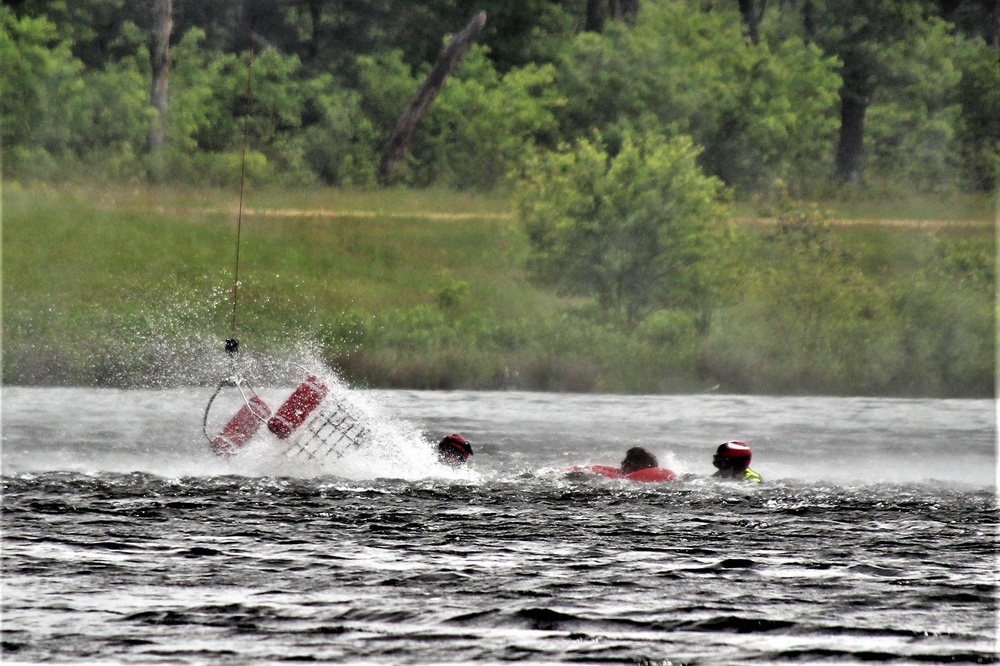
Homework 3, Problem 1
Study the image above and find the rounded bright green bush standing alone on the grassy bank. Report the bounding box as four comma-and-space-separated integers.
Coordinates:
517, 129, 727, 325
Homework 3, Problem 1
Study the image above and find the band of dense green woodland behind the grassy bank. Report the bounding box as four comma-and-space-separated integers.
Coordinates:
0, 0, 1000, 195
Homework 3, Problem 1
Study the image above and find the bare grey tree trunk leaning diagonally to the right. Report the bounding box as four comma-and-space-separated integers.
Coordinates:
378, 12, 486, 184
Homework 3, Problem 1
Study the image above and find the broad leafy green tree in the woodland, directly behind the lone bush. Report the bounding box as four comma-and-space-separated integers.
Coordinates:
556, 2, 840, 191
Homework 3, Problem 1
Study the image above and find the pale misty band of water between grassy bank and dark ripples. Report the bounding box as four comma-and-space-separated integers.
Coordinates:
3, 368, 996, 487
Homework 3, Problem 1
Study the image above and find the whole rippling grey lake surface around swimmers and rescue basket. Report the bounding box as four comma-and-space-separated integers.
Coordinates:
2, 376, 1000, 664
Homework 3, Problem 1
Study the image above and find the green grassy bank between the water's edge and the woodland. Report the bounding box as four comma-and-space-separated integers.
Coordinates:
3, 184, 996, 396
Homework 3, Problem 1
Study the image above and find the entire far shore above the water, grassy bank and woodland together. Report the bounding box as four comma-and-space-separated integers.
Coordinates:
0, 0, 1000, 396
